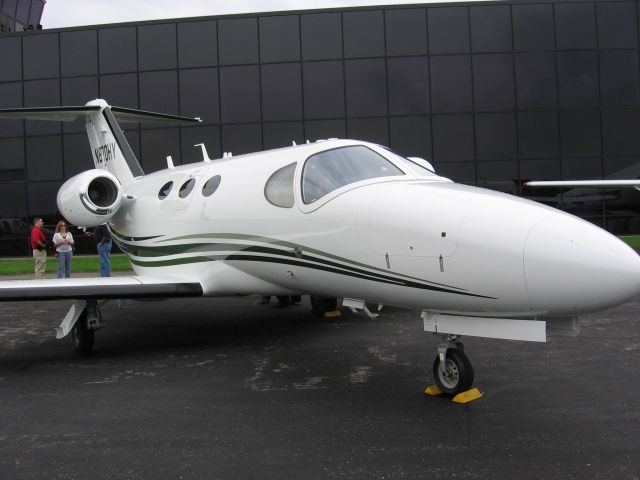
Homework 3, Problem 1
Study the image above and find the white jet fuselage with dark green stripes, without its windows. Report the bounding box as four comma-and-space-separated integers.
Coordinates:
112, 140, 640, 318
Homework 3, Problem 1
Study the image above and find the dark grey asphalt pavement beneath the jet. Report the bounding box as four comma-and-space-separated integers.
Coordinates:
0, 288, 640, 480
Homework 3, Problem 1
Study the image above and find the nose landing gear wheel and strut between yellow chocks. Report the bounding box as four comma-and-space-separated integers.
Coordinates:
433, 335, 473, 395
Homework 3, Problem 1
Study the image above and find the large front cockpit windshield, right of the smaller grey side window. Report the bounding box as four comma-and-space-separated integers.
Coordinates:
302, 145, 404, 204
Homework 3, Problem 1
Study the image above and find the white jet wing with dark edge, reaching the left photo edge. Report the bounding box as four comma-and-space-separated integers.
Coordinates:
0, 276, 202, 302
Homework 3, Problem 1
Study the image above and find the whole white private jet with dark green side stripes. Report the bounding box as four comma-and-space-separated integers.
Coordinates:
0, 99, 640, 393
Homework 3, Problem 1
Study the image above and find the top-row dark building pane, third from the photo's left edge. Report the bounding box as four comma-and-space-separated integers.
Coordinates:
60, 30, 98, 77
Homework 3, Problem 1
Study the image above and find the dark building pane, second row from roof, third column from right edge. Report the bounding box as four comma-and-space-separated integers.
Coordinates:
515, 53, 557, 110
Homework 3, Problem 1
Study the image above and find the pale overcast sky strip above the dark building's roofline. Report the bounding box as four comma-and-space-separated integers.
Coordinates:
41, 0, 484, 28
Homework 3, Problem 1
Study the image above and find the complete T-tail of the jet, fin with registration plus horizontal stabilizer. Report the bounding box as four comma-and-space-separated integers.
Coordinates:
0, 99, 201, 184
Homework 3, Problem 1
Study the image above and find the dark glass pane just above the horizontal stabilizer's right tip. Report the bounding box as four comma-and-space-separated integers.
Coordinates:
179, 68, 220, 124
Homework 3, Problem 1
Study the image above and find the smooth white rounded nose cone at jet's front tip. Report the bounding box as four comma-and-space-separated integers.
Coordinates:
524, 215, 640, 316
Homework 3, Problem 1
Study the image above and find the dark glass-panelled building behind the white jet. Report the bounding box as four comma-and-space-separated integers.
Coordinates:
0, 0, 640, 256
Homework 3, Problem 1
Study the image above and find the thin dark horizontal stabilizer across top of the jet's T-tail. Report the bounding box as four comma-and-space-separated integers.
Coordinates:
0, 105, 201, 125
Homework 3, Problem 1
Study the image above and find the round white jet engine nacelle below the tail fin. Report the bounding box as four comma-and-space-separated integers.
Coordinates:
57, 169, 122, 227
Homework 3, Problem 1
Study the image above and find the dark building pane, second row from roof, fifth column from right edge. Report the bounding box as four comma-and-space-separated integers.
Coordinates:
431, 55, 473, 113
